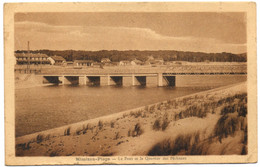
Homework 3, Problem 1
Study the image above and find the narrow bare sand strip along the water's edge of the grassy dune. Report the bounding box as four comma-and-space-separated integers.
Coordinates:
15, 82, 246, 143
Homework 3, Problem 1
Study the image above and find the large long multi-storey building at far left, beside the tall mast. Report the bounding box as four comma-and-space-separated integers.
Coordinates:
15, 53, 50, 65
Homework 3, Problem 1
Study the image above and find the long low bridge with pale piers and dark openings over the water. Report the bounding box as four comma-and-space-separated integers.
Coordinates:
15, 64, 247, 86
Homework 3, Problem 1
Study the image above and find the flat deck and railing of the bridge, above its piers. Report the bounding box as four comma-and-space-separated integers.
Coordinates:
15, 65, 247, 75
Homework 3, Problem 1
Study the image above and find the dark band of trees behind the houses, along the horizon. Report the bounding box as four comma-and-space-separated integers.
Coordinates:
15, 50, 247, 62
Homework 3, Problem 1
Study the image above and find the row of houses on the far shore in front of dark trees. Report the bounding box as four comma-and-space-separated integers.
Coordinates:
15, 53, 164, 67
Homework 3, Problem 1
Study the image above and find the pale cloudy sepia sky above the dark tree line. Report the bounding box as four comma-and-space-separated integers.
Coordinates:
14, 12, 246, 53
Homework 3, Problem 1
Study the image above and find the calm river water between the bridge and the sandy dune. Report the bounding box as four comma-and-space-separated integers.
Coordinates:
15, 76, 246, 136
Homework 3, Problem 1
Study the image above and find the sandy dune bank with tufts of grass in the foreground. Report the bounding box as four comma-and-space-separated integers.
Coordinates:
16, 83, 247, 156
